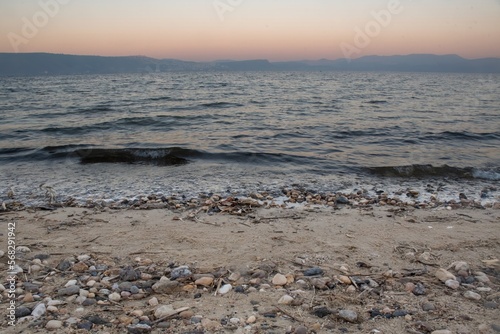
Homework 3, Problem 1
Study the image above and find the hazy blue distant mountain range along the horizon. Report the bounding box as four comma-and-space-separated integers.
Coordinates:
0, 53, 500, 76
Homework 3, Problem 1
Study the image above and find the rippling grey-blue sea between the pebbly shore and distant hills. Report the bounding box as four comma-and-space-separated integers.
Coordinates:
0, 71, 500, 205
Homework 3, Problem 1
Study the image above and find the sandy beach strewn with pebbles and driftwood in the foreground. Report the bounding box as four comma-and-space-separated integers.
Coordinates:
0, 205, 500, 334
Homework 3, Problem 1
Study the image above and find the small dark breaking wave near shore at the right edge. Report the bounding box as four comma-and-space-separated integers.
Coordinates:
366, 165, 500, 180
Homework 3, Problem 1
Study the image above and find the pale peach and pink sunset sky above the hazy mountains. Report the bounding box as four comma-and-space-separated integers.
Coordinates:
0, 0, 500, 61
